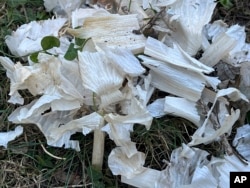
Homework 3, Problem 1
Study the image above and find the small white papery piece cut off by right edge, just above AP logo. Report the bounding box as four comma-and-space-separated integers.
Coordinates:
233, 124, 250, 161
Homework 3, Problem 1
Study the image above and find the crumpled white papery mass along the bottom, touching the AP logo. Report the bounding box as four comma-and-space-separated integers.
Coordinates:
119, 144, 250, 188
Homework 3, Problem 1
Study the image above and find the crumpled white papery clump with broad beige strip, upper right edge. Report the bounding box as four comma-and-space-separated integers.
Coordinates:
202, 20, 250, 66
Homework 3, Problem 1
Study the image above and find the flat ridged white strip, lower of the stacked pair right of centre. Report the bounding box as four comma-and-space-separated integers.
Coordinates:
139, 55, 220, 101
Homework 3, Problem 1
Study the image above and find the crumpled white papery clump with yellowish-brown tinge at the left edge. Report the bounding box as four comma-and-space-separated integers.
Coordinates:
1, 53, 98, 150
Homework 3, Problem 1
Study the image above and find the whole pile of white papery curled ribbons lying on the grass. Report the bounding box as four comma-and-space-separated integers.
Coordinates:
0, 0, 250, 188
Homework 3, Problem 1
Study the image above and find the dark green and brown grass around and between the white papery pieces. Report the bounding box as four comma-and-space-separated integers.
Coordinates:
0, 0, 250, 188
